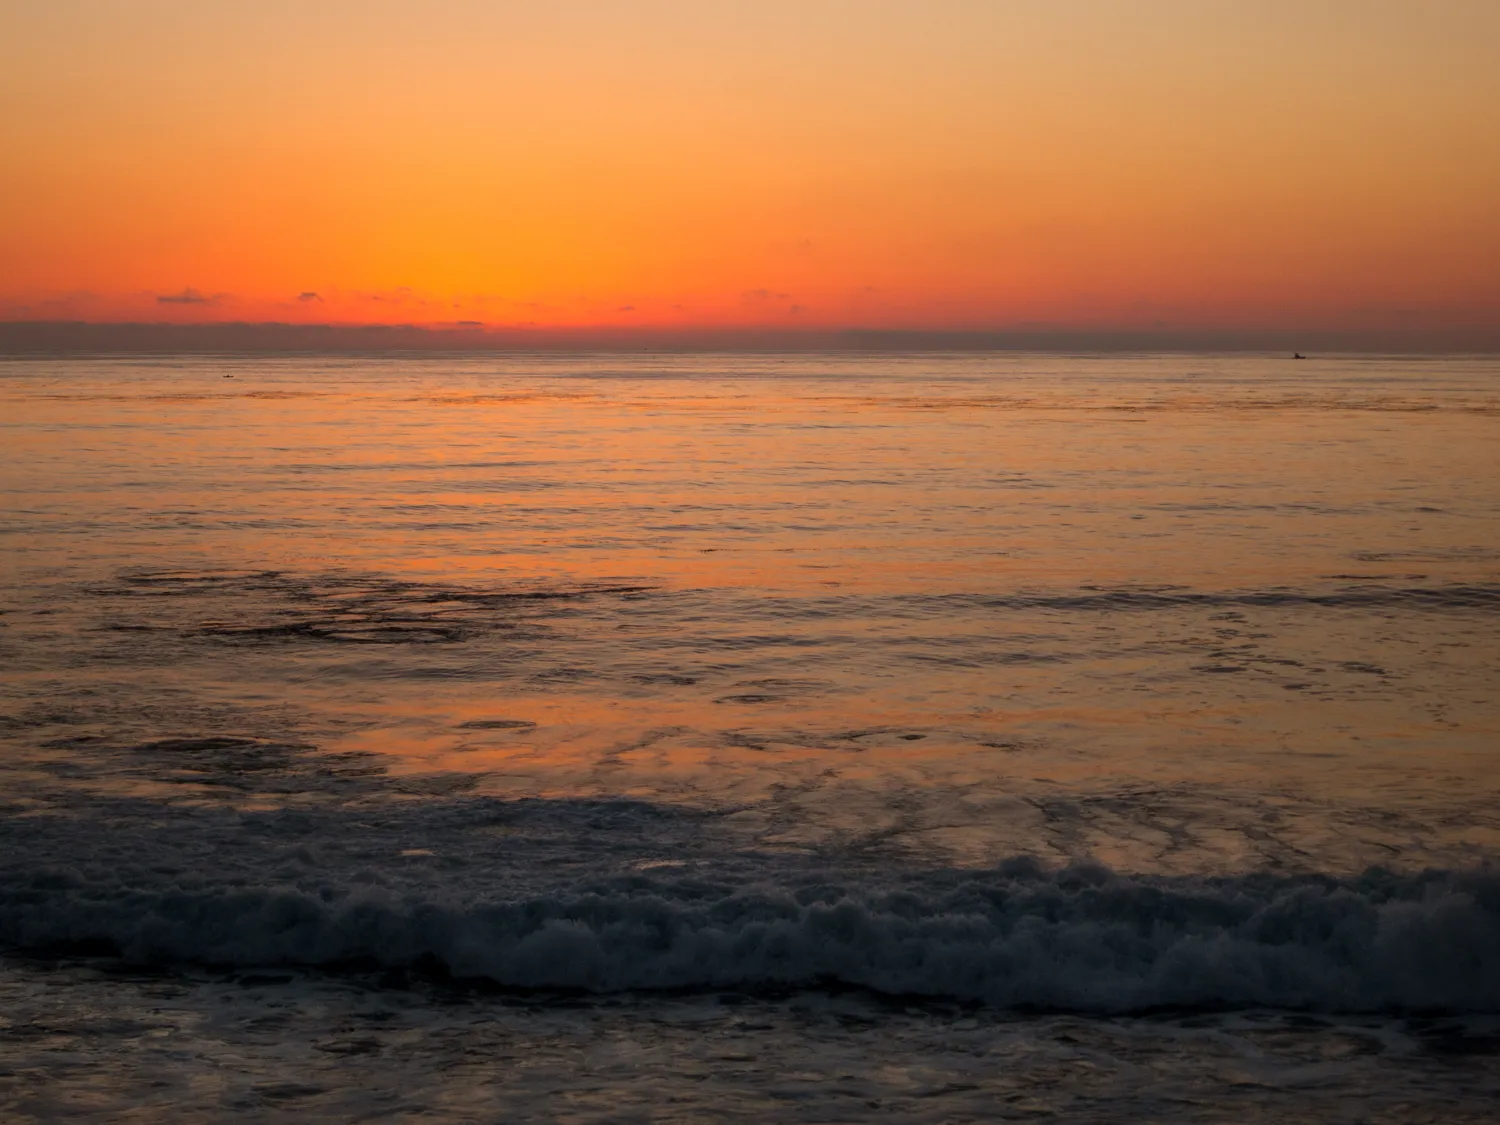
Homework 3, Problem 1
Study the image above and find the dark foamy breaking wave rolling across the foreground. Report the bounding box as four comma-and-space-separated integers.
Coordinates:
0, 860, 1500, 1013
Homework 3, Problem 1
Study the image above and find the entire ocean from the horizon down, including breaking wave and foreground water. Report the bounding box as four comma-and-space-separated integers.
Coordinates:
0, 353, 1500, 1124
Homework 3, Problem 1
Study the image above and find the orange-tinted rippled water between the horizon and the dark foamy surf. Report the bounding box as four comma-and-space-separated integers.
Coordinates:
0, 356, 1500, 869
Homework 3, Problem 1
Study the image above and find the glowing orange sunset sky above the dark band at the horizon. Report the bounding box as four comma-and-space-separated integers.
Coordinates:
0, 0, 1500, 337
